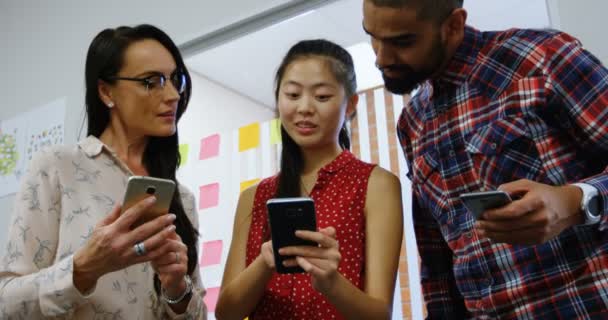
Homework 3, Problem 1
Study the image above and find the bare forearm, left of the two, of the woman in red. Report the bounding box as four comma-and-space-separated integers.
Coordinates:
215, 255, 274, 320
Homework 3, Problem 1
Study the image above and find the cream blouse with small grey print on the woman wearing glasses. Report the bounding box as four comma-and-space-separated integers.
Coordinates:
0, 137, 207, 320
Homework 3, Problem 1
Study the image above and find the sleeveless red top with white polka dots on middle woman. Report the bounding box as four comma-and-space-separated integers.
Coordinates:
247, 151, 375, 320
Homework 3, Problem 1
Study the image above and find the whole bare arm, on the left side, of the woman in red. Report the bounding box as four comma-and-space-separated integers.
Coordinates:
215, 186, 274, 320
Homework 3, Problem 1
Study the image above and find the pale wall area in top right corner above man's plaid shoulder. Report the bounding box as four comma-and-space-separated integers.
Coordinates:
547, 0, 608, 64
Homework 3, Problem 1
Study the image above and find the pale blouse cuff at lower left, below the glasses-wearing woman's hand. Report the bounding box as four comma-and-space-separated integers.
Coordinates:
39, 254, 95, 317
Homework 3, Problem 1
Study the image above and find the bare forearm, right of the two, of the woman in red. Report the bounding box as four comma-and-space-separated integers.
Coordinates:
325, 274, 392, 319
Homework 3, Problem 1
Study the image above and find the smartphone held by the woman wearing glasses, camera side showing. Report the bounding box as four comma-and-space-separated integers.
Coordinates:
121, 176, 175, 228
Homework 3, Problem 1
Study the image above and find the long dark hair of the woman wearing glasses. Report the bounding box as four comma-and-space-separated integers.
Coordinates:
85, 24, 198, 291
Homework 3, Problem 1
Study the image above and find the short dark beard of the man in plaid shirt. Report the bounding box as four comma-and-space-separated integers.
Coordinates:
379, 37, 446, 95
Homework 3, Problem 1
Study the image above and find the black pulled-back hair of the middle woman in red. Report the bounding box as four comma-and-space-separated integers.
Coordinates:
274, 39, 357, 198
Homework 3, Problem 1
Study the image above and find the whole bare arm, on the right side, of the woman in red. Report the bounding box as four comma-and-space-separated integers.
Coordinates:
326, 167, 403, 319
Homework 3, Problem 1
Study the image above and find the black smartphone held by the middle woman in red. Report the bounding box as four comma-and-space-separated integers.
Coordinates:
266, 198, 318, 273
